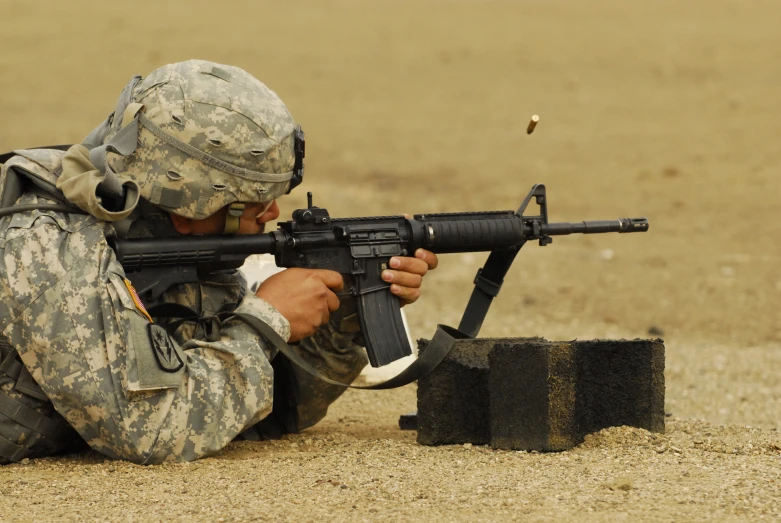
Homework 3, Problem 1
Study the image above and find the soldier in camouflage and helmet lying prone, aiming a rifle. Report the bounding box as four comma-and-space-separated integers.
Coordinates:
0, 60, 437, 464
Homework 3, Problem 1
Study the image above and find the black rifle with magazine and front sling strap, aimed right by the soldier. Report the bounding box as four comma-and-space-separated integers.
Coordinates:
109, 185, 648, 367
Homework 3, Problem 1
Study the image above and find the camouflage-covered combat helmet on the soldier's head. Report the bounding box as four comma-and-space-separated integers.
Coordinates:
84, 60, 304, 232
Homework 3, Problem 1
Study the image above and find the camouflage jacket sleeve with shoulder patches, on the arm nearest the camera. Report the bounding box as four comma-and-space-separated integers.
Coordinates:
4, 221, 285, 463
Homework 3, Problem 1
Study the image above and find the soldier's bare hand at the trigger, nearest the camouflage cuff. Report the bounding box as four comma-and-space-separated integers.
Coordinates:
255, 268, 344, 342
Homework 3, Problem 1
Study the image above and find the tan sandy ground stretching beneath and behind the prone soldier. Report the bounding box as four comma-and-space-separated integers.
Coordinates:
0, 0, 781, 521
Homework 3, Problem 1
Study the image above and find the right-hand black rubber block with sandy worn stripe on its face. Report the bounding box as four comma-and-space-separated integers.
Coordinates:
488, 340, 664, 451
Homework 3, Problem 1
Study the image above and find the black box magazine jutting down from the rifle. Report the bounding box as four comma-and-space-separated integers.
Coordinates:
357, 286, 412, 367
